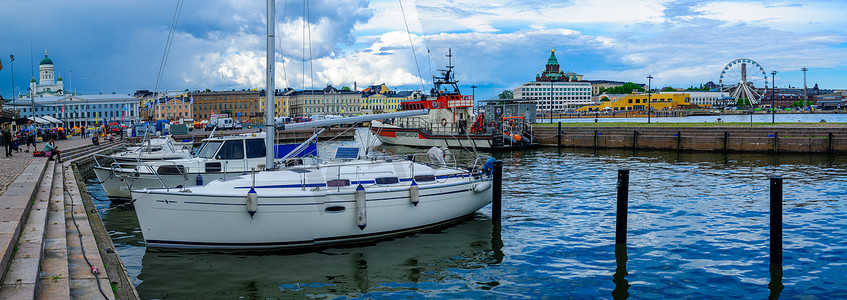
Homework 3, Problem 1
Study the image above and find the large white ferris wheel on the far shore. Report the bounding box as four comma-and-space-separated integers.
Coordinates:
719, 58, 768, 104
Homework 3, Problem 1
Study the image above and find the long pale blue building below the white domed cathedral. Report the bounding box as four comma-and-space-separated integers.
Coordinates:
7, 93, 140, 127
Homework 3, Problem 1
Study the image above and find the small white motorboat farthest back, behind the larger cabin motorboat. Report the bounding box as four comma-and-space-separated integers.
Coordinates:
109, 136, 191, 162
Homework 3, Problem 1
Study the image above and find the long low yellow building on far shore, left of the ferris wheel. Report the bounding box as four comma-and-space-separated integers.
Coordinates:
576, 94, 692, 111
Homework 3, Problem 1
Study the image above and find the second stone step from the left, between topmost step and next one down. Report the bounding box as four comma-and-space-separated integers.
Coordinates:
0, 162, 56, 299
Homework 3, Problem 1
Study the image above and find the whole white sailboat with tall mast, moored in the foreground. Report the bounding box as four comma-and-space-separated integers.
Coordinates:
132, 0, 493, 249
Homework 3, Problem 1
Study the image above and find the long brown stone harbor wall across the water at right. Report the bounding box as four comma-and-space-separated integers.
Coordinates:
533, 126, 847, 153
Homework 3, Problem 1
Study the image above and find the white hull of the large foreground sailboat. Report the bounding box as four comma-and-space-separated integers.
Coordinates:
132, 180, 492, 249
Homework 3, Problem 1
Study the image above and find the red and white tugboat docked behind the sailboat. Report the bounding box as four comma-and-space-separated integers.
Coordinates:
371, 52, 534, 149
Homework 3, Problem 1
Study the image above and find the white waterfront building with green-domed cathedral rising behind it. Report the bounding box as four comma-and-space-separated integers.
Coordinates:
512, 50, 592, 113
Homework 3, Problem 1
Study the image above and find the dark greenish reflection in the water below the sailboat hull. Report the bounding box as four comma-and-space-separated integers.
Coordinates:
138, 214, 502, 299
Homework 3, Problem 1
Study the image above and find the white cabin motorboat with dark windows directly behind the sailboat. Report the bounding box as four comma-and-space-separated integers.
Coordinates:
94, 133, 282, 198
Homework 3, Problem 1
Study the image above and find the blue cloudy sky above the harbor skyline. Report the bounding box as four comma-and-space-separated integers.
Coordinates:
0, 0, 847, 99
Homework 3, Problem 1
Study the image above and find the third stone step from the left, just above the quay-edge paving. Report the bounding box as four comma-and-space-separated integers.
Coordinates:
36, 162, 71, 299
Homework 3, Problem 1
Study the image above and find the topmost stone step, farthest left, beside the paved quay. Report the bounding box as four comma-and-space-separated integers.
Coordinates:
0, 160, 49, 290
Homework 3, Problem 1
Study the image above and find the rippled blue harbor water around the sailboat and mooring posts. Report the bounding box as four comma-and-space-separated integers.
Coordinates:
87, 131, 847, 299
